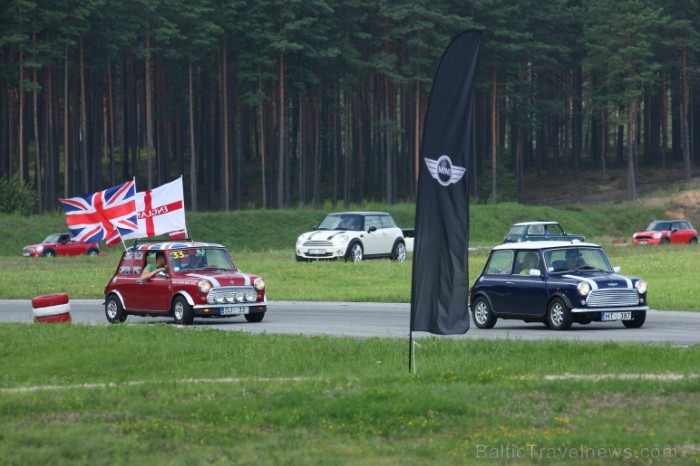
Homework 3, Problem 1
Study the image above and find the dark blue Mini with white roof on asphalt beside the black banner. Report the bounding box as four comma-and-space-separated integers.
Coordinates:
469, 241, 649, 330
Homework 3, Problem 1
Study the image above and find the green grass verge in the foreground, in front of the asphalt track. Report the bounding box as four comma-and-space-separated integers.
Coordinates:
0, 324, 700, 465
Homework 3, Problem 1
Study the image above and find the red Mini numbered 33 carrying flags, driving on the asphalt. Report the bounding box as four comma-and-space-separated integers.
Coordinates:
105, 242, 267, 325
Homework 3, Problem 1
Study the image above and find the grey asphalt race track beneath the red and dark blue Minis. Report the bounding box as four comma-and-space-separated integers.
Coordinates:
0, 299, 700, 345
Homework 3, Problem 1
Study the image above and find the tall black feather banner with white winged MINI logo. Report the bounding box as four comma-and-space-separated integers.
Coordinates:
411, 31, 481, 335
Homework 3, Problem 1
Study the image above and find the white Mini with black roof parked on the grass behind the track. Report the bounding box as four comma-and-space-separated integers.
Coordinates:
296, 212, 413, 262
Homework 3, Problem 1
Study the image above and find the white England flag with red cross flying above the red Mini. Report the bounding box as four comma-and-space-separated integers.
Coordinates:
122, 177, 187, 244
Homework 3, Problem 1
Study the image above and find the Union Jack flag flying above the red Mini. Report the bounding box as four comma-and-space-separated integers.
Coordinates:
59, 180, 138, 247
